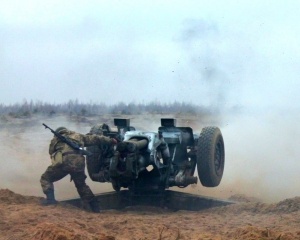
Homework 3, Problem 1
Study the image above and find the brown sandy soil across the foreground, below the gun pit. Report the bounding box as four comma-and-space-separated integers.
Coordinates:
0, 189, 300, 240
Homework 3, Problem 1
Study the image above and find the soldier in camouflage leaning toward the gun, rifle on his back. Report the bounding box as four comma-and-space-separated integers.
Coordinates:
40, 127, 117, 212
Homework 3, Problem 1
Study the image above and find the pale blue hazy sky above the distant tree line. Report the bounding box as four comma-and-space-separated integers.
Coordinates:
0, 0, 300, 110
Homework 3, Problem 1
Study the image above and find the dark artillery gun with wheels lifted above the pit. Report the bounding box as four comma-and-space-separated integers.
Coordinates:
87, 118, 225, 194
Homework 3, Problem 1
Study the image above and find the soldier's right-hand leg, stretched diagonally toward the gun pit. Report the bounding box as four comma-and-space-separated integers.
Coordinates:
71, 171, 100, 212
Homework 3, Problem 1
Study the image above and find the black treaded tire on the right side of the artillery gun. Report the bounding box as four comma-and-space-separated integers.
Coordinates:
197, 127, 225, 187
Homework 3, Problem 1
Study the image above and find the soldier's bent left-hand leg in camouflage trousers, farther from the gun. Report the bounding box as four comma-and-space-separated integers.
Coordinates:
40, 165, 68, 205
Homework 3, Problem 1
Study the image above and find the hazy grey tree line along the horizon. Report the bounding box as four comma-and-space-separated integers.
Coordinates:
0, 99, 208, 117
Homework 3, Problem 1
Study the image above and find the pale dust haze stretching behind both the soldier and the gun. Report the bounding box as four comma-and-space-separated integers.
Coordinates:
0, 113, 300, 202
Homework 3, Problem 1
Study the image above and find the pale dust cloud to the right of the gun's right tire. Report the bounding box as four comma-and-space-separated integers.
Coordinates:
182, 112, 300, 202
